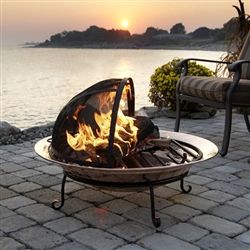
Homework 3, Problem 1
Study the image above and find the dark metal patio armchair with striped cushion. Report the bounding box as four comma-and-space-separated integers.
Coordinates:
175, 31, 250, 156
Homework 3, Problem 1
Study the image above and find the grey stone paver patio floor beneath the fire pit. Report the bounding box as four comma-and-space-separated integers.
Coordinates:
0, 112, 250, 250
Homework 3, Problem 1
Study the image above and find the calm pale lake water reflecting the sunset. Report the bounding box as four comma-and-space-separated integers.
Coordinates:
0, 48, 223, 128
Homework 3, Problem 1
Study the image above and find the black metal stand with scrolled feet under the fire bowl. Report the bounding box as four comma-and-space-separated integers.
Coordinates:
51, 172, 192, 227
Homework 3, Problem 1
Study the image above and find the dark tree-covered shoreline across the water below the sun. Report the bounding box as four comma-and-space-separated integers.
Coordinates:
33, 19, 235, 51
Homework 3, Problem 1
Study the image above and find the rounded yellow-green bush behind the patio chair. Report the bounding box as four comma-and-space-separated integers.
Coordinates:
148, 58, 214, 110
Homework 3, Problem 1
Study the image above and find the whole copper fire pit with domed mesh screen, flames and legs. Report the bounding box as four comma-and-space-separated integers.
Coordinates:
35, 78, 218, 227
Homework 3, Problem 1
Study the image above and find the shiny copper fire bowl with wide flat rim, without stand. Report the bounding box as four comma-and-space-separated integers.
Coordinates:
35, 131, 218, 187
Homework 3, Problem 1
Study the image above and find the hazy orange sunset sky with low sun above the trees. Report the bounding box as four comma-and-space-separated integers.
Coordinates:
0, 0, 250, 44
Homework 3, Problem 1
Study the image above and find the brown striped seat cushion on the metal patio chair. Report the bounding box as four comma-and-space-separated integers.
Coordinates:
180, 76, 250, 105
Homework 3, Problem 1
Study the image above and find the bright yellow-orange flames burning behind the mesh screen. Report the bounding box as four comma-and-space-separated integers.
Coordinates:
66, 86, 138, 162
